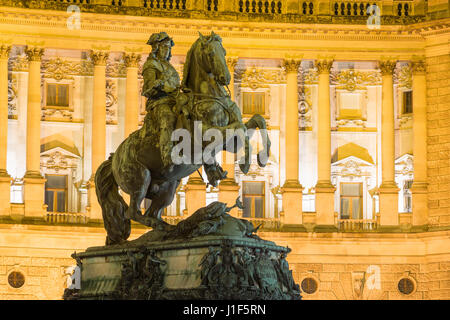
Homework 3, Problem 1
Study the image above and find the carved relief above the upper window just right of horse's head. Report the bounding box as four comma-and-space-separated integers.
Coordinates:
235, 67, 286, 90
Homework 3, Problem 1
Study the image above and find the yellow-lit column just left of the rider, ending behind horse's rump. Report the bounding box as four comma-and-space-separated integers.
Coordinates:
124, 53, 141, 138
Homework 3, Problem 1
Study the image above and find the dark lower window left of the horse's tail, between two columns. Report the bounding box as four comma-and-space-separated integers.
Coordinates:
45, 175, 67, 212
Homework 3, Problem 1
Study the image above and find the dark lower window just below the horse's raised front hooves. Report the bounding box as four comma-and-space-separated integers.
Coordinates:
242, 181, 264, 218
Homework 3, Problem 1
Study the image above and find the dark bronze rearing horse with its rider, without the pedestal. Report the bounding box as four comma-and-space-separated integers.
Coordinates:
95, 32, 270, 245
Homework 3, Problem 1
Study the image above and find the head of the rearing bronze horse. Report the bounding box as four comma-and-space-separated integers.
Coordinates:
199, 31, 231, 86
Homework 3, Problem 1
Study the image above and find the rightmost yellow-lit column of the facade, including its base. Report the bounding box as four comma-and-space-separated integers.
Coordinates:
411, 59, 428, 225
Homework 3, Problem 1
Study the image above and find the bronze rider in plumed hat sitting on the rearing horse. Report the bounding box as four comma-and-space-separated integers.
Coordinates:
142, 32, 180, 168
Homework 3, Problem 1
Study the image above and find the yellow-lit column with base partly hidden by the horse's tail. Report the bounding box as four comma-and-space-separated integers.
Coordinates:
88, 51, 109, 220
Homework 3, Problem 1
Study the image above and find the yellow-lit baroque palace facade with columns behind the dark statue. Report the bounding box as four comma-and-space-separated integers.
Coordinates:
0, 0, 450, 299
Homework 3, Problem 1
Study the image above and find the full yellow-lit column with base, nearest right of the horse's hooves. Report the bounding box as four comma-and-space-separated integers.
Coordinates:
281, 59, 303, 224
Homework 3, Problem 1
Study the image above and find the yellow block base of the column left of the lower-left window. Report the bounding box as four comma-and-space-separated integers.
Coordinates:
23, 174, 46, 219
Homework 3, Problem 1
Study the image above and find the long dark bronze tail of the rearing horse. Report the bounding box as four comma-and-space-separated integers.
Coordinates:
95, 154, 131, 245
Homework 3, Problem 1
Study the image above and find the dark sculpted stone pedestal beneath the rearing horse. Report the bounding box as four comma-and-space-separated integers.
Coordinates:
64, 202, 301, 300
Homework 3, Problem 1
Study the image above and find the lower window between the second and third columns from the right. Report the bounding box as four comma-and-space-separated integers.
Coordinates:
341, 183, 362, 219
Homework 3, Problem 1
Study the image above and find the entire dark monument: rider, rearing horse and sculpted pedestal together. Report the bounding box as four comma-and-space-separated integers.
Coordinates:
65, 32, 300, 299
